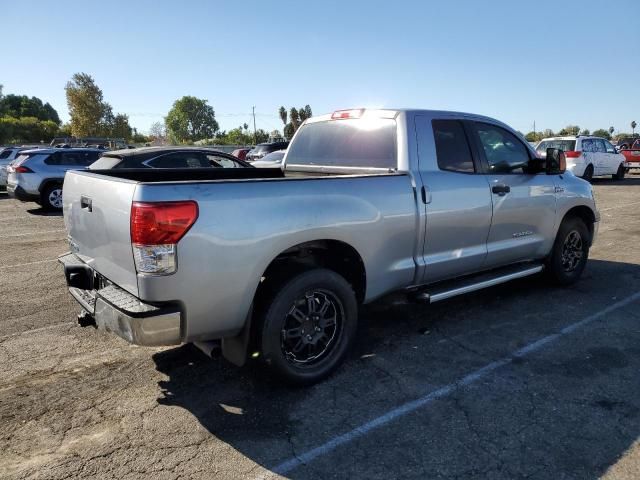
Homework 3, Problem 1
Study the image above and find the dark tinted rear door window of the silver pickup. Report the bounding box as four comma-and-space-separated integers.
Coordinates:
432, 120, 475, 173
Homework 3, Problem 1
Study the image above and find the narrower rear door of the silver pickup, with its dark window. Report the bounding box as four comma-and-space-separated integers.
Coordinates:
415, 115, 491, 283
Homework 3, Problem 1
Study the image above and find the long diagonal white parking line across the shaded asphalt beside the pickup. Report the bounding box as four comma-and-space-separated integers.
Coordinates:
257, 292, 640, 479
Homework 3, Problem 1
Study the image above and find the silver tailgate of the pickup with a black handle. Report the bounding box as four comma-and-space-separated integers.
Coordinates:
62, 171, 138, 295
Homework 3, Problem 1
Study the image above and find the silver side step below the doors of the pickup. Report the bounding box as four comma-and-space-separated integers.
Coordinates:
413, 263, 544, 303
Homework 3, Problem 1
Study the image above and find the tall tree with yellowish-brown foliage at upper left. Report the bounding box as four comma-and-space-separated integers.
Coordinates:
65, 73, 112, 137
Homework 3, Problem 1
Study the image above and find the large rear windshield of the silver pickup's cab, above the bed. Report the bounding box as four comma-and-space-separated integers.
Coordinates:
287, 118, 397, 169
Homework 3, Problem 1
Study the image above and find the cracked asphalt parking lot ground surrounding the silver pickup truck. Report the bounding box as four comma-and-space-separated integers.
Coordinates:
0, 175, 640, 480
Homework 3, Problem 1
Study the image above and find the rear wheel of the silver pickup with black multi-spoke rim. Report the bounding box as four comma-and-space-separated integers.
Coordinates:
258, 269, 358, 385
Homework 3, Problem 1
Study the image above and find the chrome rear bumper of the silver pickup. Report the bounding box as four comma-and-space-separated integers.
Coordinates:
58, 253, 182, 346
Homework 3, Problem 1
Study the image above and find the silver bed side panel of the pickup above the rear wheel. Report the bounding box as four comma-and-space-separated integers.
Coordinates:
135, 174, 416, 341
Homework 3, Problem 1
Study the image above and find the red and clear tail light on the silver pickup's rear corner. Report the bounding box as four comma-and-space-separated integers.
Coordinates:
131, 201, 198, 275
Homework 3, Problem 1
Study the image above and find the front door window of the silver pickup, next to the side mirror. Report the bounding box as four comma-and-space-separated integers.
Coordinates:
473, 122, 529, 173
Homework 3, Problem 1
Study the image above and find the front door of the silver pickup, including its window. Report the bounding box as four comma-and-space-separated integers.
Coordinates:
468, 122, 556, 268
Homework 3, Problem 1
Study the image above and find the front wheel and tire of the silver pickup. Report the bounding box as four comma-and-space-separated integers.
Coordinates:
547, 217, 591, 285
